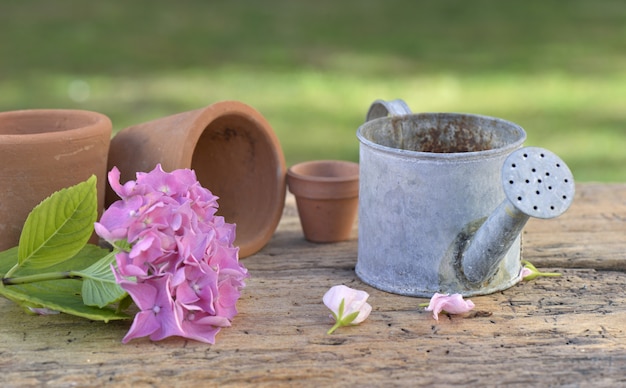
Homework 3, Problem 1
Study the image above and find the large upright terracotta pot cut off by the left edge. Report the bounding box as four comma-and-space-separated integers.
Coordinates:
0, 109, 111, 250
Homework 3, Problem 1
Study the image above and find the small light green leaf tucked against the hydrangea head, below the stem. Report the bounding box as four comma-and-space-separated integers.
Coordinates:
72, 252, 126, 307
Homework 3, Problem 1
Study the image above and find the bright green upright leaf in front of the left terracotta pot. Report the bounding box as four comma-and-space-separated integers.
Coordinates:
17, 175, 98, 269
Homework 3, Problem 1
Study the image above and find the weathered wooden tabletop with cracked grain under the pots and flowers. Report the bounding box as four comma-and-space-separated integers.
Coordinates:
0, 184, 626, 387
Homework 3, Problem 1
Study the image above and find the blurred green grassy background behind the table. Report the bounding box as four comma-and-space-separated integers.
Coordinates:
0, 0, 626, 182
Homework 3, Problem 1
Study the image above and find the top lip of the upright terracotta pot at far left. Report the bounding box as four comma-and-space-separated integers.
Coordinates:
0, 109, 112, 144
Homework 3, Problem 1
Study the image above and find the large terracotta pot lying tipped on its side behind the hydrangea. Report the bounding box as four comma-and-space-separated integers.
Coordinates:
106, 101, 286, 257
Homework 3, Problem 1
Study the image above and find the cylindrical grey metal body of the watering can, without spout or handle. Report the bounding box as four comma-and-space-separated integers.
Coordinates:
356, 98, 526, 297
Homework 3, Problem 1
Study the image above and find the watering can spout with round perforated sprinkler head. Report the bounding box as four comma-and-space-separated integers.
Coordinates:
461, 147, 575, 284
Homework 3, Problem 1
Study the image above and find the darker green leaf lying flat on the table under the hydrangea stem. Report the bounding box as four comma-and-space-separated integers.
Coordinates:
0, 279, 131, 322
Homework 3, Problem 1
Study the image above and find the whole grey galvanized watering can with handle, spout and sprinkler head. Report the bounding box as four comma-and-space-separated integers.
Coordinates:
356, 100, 575, 297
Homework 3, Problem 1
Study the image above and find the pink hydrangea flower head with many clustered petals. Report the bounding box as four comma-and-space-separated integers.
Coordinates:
95, 165, 249, 343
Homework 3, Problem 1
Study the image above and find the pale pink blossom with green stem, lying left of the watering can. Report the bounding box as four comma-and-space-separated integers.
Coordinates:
322, 285, 372, 334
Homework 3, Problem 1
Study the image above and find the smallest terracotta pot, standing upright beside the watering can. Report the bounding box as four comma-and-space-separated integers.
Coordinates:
287, 160, 359, 243
